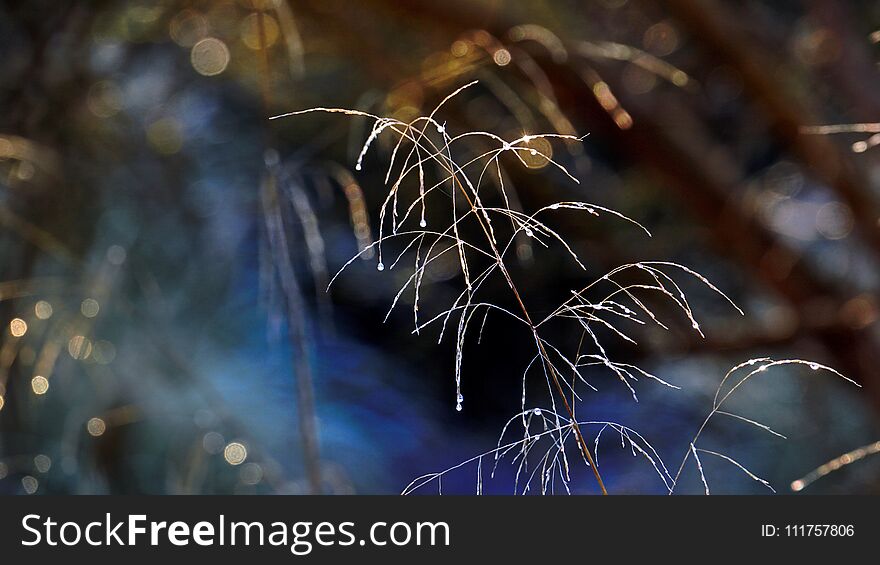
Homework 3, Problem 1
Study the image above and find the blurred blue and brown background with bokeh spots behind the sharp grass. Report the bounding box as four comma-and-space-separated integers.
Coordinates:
0, 0, 880, 494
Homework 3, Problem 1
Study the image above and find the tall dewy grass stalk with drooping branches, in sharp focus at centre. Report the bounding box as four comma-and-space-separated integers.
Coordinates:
275, 81, 756, 493
